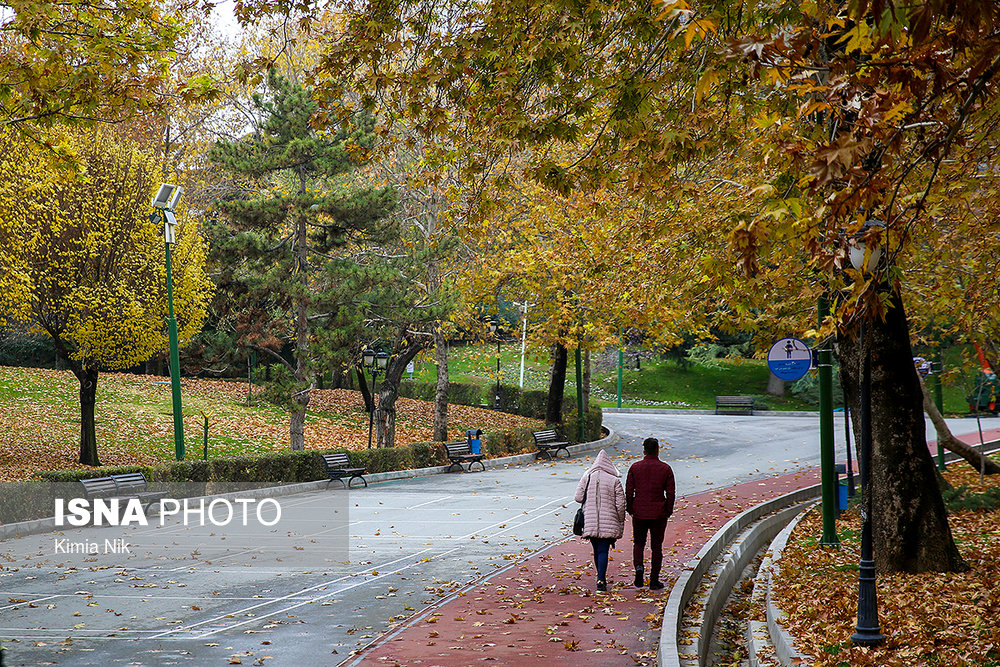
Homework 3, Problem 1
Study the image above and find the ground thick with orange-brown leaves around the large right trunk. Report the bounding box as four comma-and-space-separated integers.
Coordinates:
772, 463, 1000, 667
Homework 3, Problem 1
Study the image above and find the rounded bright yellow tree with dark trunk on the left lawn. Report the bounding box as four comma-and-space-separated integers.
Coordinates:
0, 129, 211, 465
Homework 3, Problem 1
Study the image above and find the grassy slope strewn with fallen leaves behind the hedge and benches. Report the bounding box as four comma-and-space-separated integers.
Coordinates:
0, 366, 541, 481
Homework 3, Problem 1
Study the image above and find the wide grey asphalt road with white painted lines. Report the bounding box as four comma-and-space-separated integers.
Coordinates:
0, 414, 1000, 665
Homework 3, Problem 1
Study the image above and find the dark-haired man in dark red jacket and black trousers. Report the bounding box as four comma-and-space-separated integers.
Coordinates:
625, 438, 674, 591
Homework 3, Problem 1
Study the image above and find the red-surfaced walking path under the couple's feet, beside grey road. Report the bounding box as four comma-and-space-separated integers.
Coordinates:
343, 429, 1000, 667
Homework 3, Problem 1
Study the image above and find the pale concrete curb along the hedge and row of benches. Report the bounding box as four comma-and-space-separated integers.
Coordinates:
0, 426, 620, 541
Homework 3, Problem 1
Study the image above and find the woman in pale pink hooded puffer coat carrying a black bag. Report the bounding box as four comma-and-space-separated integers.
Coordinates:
576, 449, 625, 591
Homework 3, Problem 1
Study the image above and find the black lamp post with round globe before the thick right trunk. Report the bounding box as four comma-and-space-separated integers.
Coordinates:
850, 220, 885, 646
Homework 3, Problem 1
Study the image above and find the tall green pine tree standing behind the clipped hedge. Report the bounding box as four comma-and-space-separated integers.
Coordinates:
211, 73, 396, 449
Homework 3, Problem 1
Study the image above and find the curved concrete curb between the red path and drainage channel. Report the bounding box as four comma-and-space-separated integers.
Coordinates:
657, 484, 820, 667
